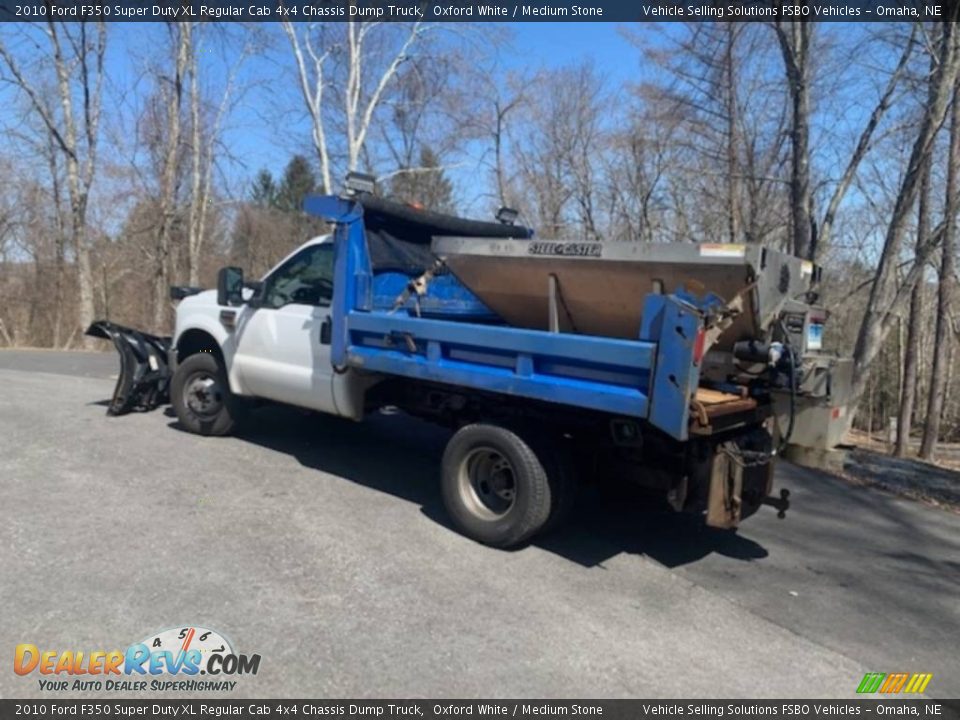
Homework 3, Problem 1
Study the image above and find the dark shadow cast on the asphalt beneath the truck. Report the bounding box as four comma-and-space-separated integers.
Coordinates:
165, 406, 768, 567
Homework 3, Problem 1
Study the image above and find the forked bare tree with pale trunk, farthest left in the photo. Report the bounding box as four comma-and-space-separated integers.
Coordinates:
0, 21, 107, 345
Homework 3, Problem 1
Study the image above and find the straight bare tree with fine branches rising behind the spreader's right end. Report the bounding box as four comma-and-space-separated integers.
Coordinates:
640, 22, 786, 248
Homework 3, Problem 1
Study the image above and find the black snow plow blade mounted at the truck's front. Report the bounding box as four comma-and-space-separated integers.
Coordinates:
86, 320, 171, 415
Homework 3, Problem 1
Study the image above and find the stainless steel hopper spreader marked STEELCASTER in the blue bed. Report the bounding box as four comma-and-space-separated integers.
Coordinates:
433, 237, 817, 349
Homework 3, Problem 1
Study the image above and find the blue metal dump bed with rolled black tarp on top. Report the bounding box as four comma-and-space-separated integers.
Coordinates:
305, 196, 716, 440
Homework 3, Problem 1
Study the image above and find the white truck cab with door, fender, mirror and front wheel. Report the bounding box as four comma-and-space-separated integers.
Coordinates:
171, 235, 369, 430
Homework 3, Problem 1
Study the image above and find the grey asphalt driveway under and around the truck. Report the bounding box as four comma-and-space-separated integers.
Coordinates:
0, 351, 960, 697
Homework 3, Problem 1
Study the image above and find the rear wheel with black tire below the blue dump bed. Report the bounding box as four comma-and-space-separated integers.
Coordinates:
441, 424, 554, 548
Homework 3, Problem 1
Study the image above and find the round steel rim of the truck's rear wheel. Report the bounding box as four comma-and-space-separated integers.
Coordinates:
457, 447, 517, 520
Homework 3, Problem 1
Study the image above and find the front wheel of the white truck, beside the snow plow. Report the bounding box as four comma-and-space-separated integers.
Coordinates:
170, 353, 240, 435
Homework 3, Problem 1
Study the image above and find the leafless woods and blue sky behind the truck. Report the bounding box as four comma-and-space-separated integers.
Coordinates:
0, 18, 960, 458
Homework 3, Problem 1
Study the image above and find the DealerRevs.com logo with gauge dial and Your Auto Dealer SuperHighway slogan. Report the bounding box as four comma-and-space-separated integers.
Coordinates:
13, 626, 260, 692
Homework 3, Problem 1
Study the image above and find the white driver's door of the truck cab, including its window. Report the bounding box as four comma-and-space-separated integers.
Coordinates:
234, 242, 337, 414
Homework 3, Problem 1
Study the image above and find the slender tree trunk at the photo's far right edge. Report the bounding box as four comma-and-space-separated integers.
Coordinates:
920, 81, 960, 460
